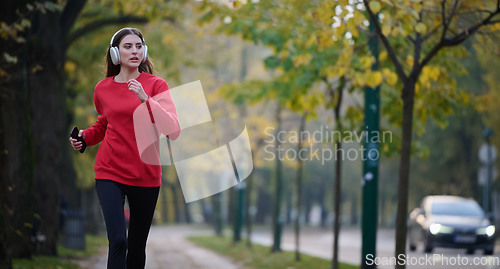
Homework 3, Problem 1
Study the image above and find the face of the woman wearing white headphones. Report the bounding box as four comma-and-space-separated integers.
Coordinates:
119, 34, 144, 69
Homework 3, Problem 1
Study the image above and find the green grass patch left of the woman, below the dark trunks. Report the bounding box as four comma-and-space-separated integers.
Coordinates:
12, 235, 108, 269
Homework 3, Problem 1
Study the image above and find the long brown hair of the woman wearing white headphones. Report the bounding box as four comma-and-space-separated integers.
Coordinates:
106, 28, 154, 77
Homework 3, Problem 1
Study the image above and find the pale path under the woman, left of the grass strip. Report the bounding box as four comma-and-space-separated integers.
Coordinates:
72, 226, 241, 269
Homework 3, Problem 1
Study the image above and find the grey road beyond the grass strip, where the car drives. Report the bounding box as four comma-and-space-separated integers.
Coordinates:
252, 228, 500, 269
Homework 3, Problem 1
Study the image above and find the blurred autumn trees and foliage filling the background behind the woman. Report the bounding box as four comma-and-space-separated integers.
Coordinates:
0, 0, 500, 264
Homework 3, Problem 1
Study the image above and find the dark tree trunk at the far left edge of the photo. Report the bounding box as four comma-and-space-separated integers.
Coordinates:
0, 61, 34, 268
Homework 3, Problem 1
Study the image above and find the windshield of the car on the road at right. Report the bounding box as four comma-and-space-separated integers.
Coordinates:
431, 201, 484, 217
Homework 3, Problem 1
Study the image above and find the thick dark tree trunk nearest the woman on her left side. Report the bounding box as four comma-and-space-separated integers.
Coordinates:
29, 18, 78, 255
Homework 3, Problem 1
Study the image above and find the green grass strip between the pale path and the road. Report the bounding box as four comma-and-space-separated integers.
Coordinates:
188, 236, 359, 269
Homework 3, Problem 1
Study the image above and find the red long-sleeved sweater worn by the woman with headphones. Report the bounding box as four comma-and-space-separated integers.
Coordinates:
84, 72, 180, 187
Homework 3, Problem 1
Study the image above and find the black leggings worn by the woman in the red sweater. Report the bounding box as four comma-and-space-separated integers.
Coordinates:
95, 179, 160, 269
